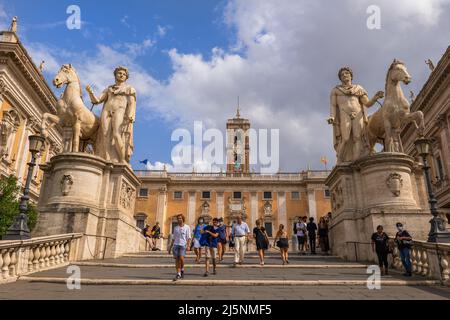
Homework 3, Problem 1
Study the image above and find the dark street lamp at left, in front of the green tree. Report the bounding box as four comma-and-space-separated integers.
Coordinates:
3, 135, 45, 240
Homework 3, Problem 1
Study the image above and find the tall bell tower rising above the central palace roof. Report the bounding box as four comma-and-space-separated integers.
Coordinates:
227, 103, 250, 174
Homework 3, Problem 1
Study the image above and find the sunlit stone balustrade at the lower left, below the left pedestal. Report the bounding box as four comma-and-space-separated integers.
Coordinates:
0, 234, 83, 284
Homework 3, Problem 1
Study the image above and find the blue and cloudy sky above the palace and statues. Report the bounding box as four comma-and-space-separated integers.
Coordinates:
0, 0, 450, 172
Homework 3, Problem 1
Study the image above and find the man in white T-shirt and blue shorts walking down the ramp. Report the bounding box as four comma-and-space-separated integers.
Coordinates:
169, 214, 191, 281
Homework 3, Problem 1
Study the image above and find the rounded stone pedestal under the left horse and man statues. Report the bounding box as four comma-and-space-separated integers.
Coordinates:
33, 153, 145, 260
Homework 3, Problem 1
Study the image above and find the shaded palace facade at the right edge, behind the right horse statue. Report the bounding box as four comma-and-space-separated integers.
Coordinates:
402, 47, 450, 219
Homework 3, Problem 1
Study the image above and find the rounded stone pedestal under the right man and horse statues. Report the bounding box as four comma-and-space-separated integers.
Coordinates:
326, 153, 431, 261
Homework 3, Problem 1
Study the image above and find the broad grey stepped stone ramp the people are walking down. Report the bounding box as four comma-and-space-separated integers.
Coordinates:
0, 253, 450, 300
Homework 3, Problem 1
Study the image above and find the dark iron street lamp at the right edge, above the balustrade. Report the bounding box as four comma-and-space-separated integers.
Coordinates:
414, 137, 450, 243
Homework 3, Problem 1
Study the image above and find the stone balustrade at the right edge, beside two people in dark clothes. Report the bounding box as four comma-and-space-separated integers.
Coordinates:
393, 241, 450, 284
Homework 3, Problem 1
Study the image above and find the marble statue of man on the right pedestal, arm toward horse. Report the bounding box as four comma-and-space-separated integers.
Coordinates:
328, 67, 384, 164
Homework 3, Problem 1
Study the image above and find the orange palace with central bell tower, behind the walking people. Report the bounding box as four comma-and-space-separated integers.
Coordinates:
135, 110, 331, 236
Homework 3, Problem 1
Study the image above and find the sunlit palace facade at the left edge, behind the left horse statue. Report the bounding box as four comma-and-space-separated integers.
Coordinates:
0, 28, 62, 202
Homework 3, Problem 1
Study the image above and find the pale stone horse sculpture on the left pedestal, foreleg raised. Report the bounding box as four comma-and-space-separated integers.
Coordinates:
41, 64, 100, 152
